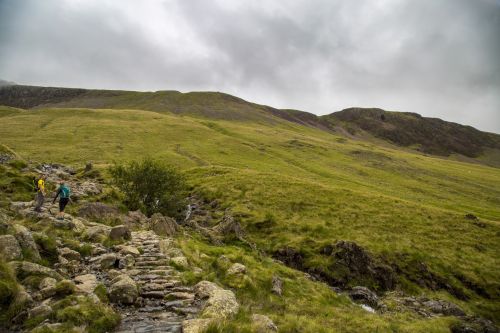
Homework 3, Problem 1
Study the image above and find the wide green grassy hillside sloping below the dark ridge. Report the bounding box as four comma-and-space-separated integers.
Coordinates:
0, 107, 500, 332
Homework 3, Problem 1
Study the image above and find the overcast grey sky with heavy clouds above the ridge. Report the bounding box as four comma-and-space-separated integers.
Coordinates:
0, 0, 500, 133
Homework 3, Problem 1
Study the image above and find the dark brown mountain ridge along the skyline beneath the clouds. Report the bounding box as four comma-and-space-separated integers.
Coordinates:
0, 85, 500, 165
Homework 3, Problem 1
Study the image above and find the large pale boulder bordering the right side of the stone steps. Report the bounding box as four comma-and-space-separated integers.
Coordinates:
194, 281, 239, 319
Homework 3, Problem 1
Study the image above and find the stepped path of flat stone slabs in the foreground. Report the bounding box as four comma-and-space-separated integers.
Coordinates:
117, 231, 200, 333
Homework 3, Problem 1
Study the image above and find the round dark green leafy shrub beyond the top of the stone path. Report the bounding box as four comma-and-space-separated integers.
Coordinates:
110, 158, 187, 217
